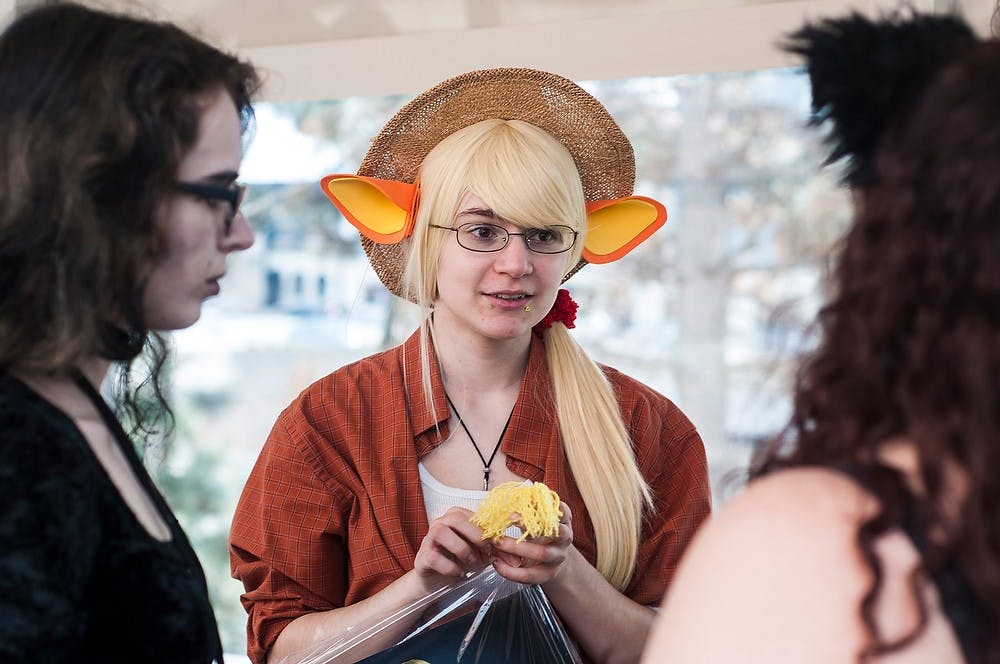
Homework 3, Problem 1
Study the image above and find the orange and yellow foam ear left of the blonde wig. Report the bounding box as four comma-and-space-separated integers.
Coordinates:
320, 174, 418, 244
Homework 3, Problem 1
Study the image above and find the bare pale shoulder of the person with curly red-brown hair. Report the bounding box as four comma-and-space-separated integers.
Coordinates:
645, 468, 874, 662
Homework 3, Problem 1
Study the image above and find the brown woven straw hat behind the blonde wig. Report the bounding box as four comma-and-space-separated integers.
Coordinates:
358, 68, 635, 297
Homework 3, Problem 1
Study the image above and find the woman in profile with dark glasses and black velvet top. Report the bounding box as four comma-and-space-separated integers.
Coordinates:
0, 3, 258, 662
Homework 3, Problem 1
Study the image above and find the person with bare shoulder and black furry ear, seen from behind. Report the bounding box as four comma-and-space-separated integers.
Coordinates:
644, 10, 1000, 663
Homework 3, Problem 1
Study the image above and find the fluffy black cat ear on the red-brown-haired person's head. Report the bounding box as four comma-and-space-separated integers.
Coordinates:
782, 12, 976, 187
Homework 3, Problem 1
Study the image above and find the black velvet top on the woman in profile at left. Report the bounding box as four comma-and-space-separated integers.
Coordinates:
0, 374, 222, 664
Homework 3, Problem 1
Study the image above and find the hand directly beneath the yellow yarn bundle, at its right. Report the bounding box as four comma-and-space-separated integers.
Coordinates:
493, 502, 573, 585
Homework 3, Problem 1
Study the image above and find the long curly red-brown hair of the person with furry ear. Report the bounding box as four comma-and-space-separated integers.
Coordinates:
755, 41, 1000, 662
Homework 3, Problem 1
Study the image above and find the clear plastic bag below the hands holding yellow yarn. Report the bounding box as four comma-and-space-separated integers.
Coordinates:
279, 566, 581, 664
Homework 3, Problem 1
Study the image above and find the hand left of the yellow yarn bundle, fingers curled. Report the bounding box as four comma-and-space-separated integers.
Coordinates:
413, 507, 492, 590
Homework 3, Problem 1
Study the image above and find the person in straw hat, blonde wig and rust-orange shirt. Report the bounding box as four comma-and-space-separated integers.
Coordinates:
231, 69, 710, 662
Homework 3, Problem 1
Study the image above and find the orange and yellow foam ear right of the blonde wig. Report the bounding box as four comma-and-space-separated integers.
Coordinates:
583, 196, 667, 263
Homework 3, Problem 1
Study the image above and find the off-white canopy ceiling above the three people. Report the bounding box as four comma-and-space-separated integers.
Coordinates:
7, 0, 995, 100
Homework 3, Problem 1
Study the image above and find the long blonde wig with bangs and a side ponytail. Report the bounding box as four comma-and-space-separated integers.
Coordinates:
403, 119, 652, 590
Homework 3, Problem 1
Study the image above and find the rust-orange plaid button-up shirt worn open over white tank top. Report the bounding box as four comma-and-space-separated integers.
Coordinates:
230, 333, 711, 662
